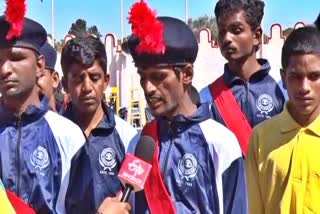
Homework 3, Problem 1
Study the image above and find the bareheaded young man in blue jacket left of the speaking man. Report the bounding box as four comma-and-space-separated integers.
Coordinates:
61, 36, 138, 213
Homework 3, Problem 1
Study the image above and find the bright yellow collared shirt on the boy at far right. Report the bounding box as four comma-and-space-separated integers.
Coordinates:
246, 105, 320, 214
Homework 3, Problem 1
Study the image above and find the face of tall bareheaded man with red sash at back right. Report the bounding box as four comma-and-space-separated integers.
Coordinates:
218, 11, 262, 81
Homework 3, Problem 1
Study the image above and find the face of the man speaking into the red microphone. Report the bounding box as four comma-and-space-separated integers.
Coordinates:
138, 64, 196, 120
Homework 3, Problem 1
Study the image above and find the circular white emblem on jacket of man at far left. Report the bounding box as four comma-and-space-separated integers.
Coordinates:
30, 146, 50, 170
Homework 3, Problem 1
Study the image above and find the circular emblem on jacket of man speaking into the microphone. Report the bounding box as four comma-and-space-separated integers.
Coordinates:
178, 153, 198, 181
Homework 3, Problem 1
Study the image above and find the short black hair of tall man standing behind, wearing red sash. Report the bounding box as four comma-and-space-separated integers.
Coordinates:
214, 0, 264, 30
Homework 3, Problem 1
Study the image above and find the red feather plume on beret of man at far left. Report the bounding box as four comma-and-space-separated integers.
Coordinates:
5, 0, 26, 40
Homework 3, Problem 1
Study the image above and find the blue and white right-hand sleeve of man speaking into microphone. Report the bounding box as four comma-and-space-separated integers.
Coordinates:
200, 120, 248, 214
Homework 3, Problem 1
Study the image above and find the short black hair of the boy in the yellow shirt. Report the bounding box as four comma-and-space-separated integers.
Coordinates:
281, 26, 320, 69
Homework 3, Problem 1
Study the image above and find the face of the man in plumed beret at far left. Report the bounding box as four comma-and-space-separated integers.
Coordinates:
0, 47, 44, 112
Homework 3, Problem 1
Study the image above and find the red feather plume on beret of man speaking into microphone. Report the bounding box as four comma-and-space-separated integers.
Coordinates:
128, 0, 165, 54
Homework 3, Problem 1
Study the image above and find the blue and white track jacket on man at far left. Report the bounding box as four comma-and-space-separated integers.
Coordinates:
0, 98, 85, 213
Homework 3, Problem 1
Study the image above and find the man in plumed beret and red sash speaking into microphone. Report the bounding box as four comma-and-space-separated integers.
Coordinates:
128, 1, 247, 214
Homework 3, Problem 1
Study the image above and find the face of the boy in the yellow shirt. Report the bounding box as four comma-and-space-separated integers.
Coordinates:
281, 54, 320, 126
